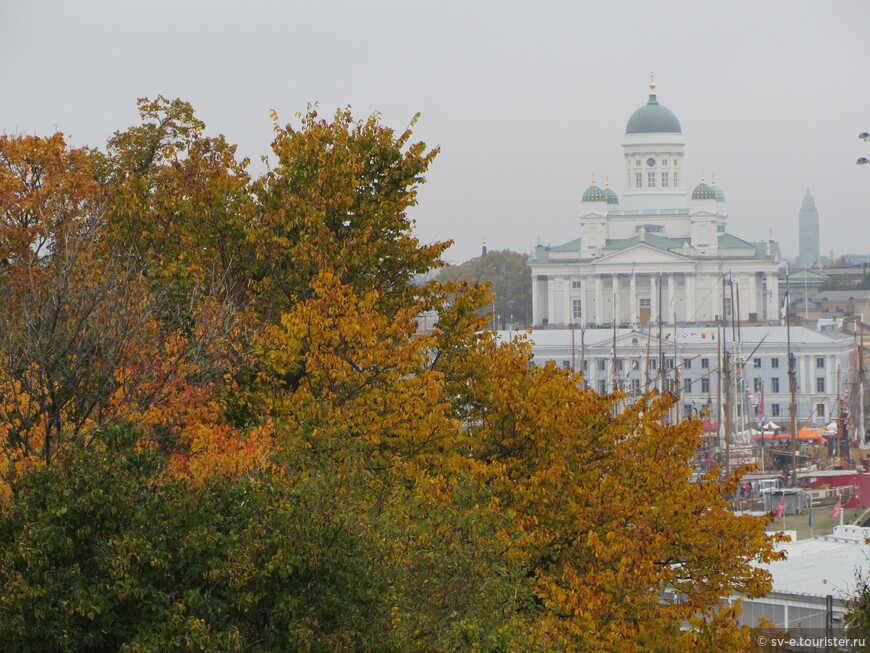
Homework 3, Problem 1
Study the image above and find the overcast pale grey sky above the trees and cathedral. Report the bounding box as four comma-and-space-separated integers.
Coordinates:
0, 0, 870, 261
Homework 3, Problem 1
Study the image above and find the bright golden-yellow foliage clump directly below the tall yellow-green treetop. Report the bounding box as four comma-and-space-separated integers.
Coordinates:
257, 271, 458, 472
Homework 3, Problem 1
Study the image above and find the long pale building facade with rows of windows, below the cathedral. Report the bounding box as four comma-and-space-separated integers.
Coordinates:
499, 325, 853, 428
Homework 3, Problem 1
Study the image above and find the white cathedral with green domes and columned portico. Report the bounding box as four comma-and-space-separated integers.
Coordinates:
529, 81, 781, 328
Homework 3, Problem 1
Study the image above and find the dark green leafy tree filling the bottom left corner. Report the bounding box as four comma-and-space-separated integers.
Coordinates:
0, 426, 403, 653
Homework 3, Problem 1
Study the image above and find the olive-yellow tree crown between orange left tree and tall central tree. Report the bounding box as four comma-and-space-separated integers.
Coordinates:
106, 96, 250, 299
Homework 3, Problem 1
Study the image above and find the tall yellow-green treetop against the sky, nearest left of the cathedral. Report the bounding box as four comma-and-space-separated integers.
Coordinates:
247, 108, 450, 315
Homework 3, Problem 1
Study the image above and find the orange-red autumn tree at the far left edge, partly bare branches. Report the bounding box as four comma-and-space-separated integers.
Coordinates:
0, 121, 268, 494
